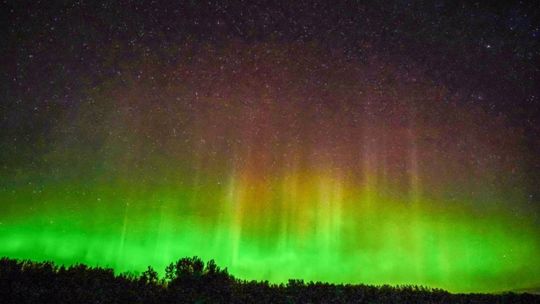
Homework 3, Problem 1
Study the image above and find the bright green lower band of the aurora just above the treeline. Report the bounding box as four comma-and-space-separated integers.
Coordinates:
0, 179, 540, 291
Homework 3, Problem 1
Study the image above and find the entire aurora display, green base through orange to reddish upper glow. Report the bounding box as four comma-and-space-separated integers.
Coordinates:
0, 45, 540, 292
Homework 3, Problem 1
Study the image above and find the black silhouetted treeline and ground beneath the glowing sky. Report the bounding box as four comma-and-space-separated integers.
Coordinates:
0, 257, 540, 304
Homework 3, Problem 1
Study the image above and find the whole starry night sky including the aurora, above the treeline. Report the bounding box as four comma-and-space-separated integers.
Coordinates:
0, 1, 540, 292
